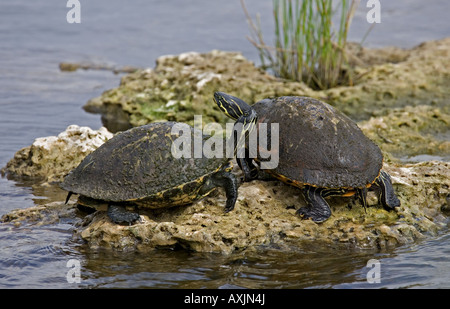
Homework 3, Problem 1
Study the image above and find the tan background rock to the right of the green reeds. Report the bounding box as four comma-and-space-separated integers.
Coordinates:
323, 38, 450, 120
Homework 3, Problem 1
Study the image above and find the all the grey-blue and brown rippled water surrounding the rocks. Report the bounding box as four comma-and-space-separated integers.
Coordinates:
0, 0, 450, 288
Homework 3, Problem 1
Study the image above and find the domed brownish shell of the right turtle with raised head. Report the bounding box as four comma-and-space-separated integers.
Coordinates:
253, 97, 383, 188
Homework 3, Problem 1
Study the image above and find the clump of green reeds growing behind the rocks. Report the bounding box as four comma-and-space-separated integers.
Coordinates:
241, 0, 359, 89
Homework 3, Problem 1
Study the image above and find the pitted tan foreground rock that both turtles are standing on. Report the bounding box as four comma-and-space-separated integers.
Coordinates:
73, 161, 450, 254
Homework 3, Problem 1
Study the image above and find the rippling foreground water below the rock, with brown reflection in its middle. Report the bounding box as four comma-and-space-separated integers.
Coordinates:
0, 179, 450, 289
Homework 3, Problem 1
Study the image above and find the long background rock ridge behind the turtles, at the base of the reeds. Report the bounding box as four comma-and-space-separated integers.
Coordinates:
84, 38, 450, 132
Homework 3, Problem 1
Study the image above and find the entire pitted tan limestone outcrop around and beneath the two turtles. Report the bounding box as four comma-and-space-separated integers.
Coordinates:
0, 39, 450, 253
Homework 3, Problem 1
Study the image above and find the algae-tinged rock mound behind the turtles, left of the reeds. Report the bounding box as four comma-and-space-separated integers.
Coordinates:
84, 51, 312, 132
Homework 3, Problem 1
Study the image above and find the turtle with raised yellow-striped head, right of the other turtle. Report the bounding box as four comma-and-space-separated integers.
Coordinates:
214, 92, 400, 223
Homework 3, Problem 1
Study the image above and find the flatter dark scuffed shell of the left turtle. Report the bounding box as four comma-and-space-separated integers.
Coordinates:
61, 122, 228, 208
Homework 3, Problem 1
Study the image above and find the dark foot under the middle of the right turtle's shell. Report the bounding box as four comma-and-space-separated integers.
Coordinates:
296, 186, 331, 223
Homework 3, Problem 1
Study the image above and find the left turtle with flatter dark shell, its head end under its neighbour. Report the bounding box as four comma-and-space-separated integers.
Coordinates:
60, 121, 238, 224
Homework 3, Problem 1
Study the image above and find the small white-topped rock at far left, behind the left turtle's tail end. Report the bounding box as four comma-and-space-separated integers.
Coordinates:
1, 125, 113, 182
